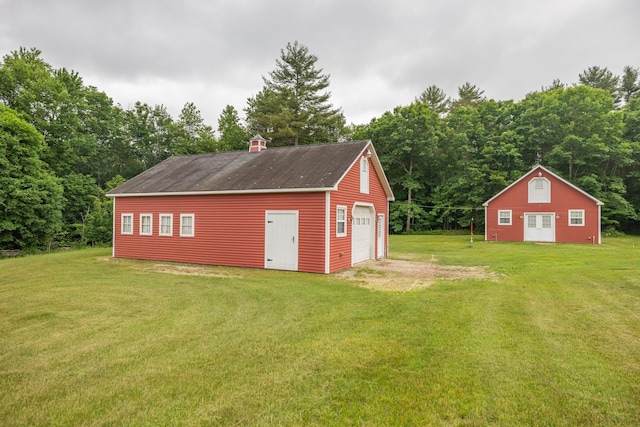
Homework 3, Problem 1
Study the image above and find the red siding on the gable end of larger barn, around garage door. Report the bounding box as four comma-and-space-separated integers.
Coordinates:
329, 158, 389, 272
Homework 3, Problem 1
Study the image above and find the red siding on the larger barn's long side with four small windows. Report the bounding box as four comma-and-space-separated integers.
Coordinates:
114, 193, 325, 273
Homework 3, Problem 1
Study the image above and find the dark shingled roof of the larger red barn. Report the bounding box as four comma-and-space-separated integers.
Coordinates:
107, 141, 393, 199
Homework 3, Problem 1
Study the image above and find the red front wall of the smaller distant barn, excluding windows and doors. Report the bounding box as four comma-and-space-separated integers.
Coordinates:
485, 169, 600, 243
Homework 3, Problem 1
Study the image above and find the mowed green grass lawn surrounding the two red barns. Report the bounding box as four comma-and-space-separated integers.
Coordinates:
0, 236, 640, 426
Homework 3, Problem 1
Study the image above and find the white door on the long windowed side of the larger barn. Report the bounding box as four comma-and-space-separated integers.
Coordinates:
264, 211, 298, 271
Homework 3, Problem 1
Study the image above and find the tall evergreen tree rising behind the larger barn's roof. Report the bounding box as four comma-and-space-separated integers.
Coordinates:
245, 41, 345, 146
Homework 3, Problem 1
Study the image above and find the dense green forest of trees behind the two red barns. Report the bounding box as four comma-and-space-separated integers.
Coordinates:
0, 42, 640, 250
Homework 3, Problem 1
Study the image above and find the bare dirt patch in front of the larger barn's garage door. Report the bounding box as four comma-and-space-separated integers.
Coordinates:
336, 257, 497, 292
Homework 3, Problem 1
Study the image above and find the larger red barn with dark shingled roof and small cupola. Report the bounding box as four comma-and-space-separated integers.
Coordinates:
107, 139, 393, 273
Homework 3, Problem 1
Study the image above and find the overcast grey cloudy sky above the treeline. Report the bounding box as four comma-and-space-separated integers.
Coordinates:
0, 0, 640, 128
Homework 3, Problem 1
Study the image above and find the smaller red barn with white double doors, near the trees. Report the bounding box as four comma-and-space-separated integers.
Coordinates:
483, 165, 603, 244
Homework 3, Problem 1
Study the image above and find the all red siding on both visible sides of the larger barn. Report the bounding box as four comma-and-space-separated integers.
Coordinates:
114, 149, 389, 273
